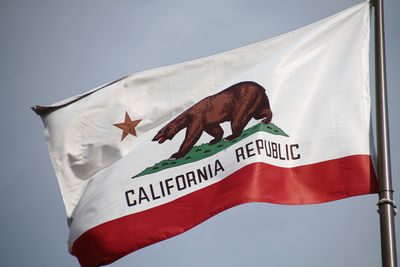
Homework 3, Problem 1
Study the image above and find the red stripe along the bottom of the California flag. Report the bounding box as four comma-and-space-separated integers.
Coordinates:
71, 155, 378, 267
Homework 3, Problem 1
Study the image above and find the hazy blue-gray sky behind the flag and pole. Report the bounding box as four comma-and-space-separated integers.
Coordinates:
0, 0, 400, 267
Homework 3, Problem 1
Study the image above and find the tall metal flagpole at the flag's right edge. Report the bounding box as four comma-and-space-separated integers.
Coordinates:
374, 0, 397, 267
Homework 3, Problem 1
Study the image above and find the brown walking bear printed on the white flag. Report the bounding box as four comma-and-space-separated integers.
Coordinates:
152, 81, 272, 159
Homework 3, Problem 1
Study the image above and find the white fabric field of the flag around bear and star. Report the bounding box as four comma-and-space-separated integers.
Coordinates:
39, 2, 371, 242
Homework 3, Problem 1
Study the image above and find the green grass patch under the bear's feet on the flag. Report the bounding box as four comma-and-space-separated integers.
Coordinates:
132, 122, 288, 178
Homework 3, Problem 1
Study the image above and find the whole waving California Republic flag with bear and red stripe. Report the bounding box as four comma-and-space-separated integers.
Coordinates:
35, 2, 377, 266
